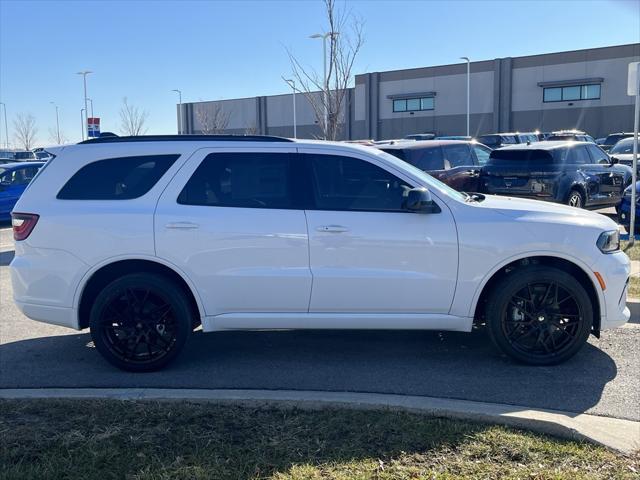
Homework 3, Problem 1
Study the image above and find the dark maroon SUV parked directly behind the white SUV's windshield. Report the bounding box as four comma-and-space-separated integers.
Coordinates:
378, 140, 491, 192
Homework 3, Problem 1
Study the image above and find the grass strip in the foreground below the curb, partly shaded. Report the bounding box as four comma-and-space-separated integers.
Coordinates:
0, 400, 640, 480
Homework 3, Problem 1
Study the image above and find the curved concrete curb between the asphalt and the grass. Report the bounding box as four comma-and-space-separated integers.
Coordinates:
0, 388, 640, 454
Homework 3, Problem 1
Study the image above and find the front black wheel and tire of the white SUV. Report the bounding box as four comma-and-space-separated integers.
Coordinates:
486, 266, 593, 365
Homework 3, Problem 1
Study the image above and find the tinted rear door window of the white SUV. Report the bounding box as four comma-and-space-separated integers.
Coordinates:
178, 152, 294, 208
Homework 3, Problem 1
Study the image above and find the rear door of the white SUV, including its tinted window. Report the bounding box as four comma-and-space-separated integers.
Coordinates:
155, 147, 311, 316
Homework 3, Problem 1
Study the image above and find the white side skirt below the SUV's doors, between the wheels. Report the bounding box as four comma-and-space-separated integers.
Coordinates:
202, 313, 473, 332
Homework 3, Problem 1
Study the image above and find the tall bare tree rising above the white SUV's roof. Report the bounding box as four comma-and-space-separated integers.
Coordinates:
287, 0, 364, 140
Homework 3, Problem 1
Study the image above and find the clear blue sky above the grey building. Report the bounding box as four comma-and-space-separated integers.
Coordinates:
0, 0, 640, 144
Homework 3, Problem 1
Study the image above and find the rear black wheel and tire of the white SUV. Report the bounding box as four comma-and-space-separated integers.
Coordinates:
89, 273, 193, 372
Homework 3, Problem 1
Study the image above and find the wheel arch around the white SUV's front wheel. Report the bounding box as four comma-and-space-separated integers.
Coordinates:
472, 252, 606, 337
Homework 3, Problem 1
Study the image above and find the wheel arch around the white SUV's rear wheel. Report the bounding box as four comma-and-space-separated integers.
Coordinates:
74, 256, 205, 329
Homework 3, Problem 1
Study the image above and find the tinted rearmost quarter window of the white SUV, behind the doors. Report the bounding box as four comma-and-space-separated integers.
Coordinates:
57, 155, 180, 200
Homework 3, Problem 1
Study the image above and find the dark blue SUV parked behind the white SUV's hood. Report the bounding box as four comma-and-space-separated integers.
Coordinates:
479, 141, 631, 208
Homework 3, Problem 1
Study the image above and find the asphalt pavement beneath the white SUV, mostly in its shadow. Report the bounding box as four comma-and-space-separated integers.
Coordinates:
0, 228, 640, 420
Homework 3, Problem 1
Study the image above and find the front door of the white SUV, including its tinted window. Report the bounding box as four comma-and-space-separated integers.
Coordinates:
302, 149, 458, 314
